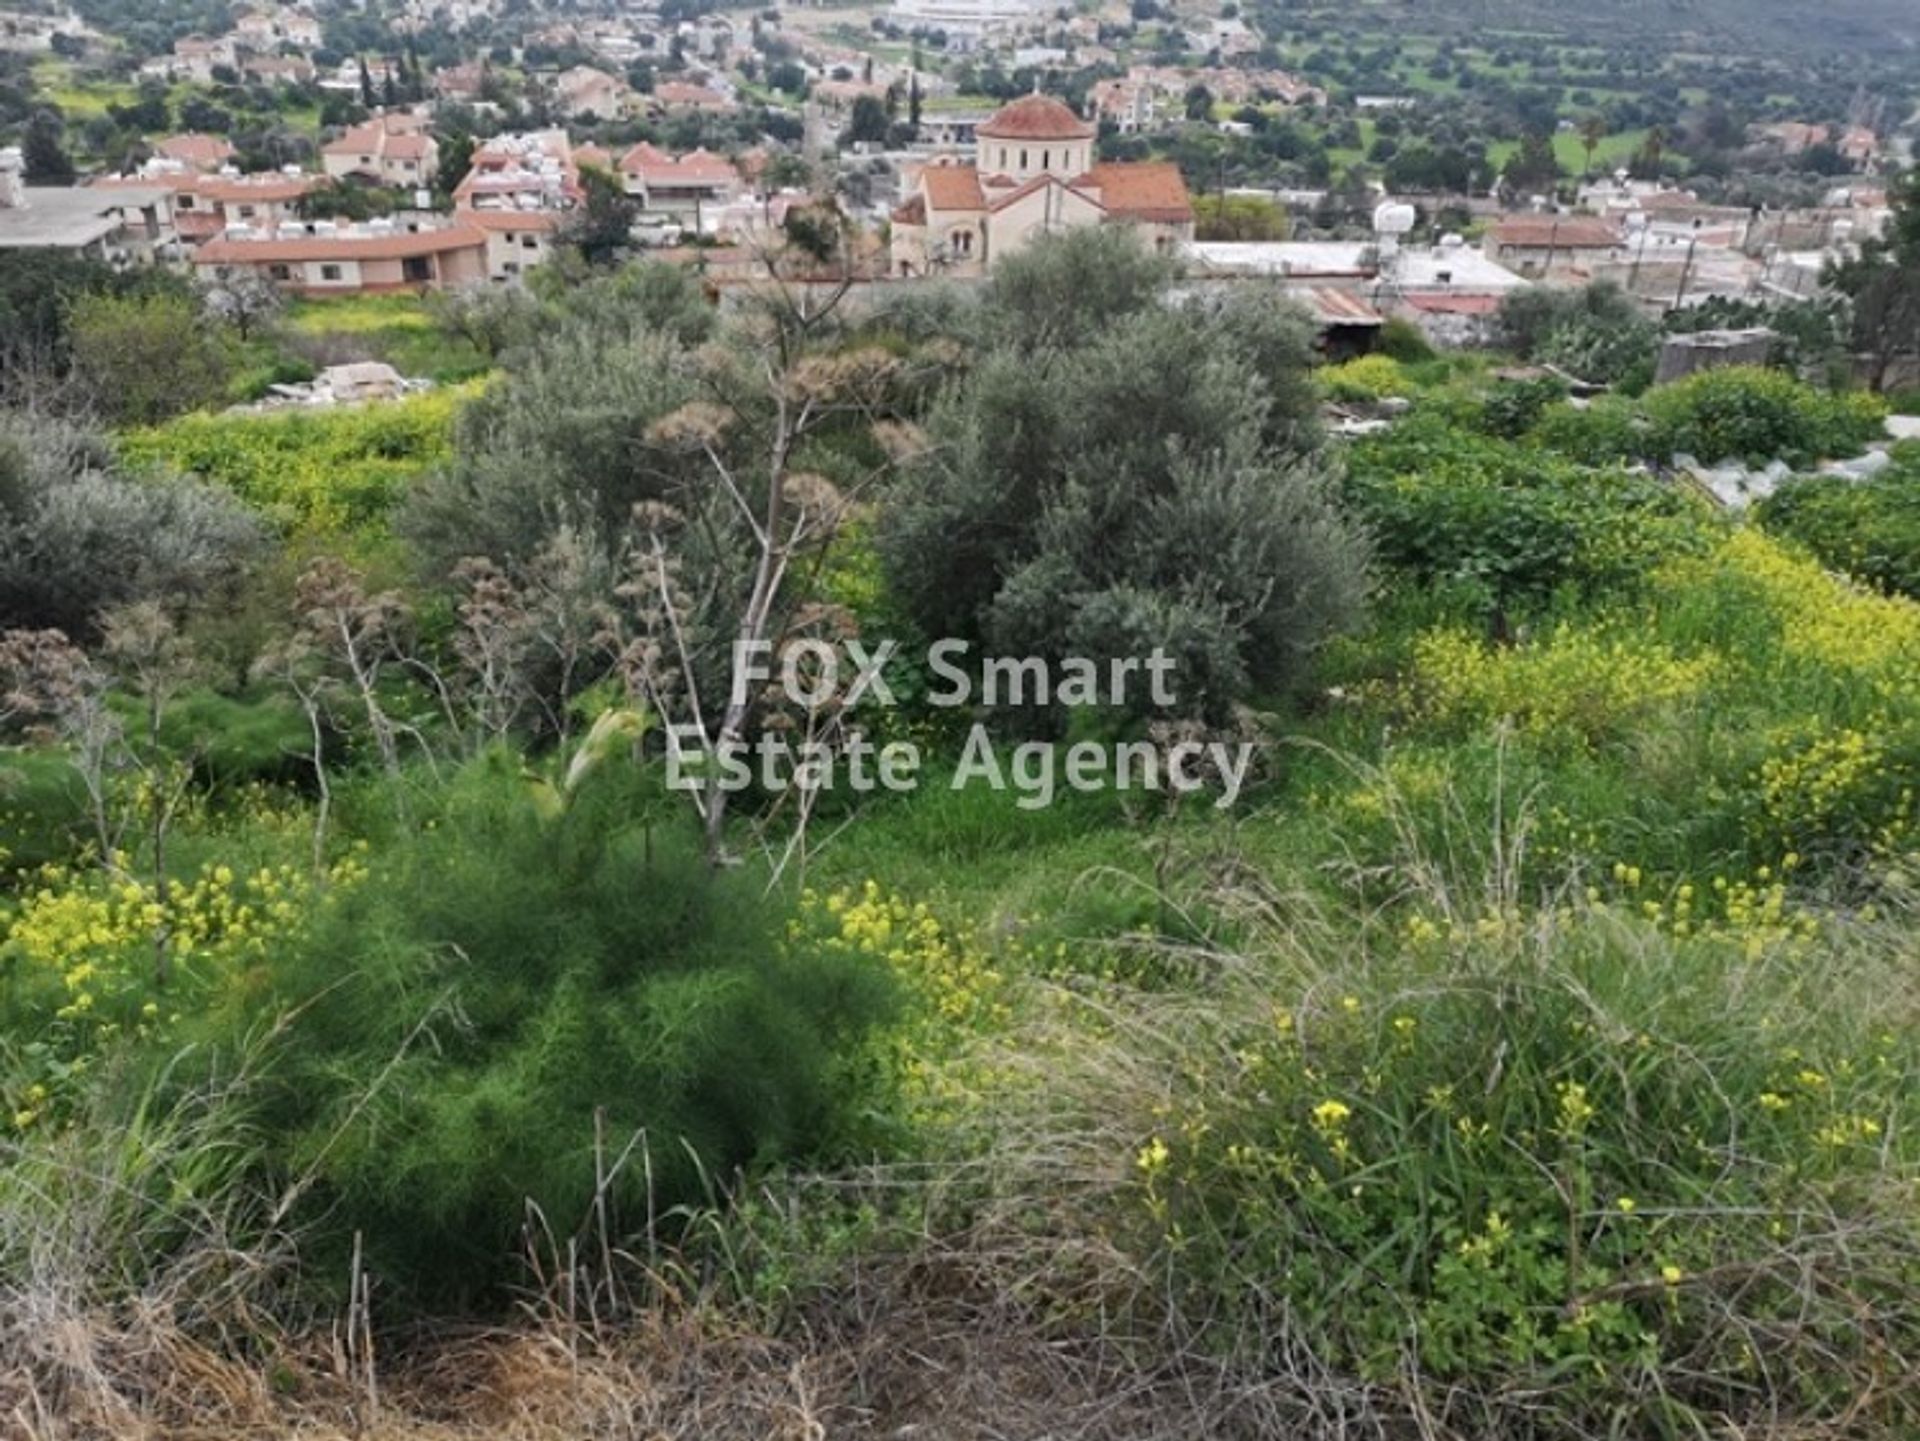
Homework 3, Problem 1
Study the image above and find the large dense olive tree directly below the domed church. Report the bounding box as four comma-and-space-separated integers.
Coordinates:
881, 232, 1365, 720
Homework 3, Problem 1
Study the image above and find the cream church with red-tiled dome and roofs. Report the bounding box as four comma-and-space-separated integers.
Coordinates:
891, 94, 1194, 276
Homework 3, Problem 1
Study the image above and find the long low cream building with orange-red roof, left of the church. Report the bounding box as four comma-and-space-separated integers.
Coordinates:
194, 219, 488, 295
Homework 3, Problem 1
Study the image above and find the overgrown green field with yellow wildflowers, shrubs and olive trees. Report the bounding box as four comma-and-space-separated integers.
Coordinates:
0, 232, 1920, 1439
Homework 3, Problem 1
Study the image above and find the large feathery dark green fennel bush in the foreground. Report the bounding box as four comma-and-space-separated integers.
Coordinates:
217, 756, 887, 1299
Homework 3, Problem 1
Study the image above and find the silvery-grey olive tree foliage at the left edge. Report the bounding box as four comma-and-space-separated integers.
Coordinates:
0, 411, 261, 639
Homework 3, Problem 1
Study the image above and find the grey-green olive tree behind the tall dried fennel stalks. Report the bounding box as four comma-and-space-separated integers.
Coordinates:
401, 262, 910, 856
